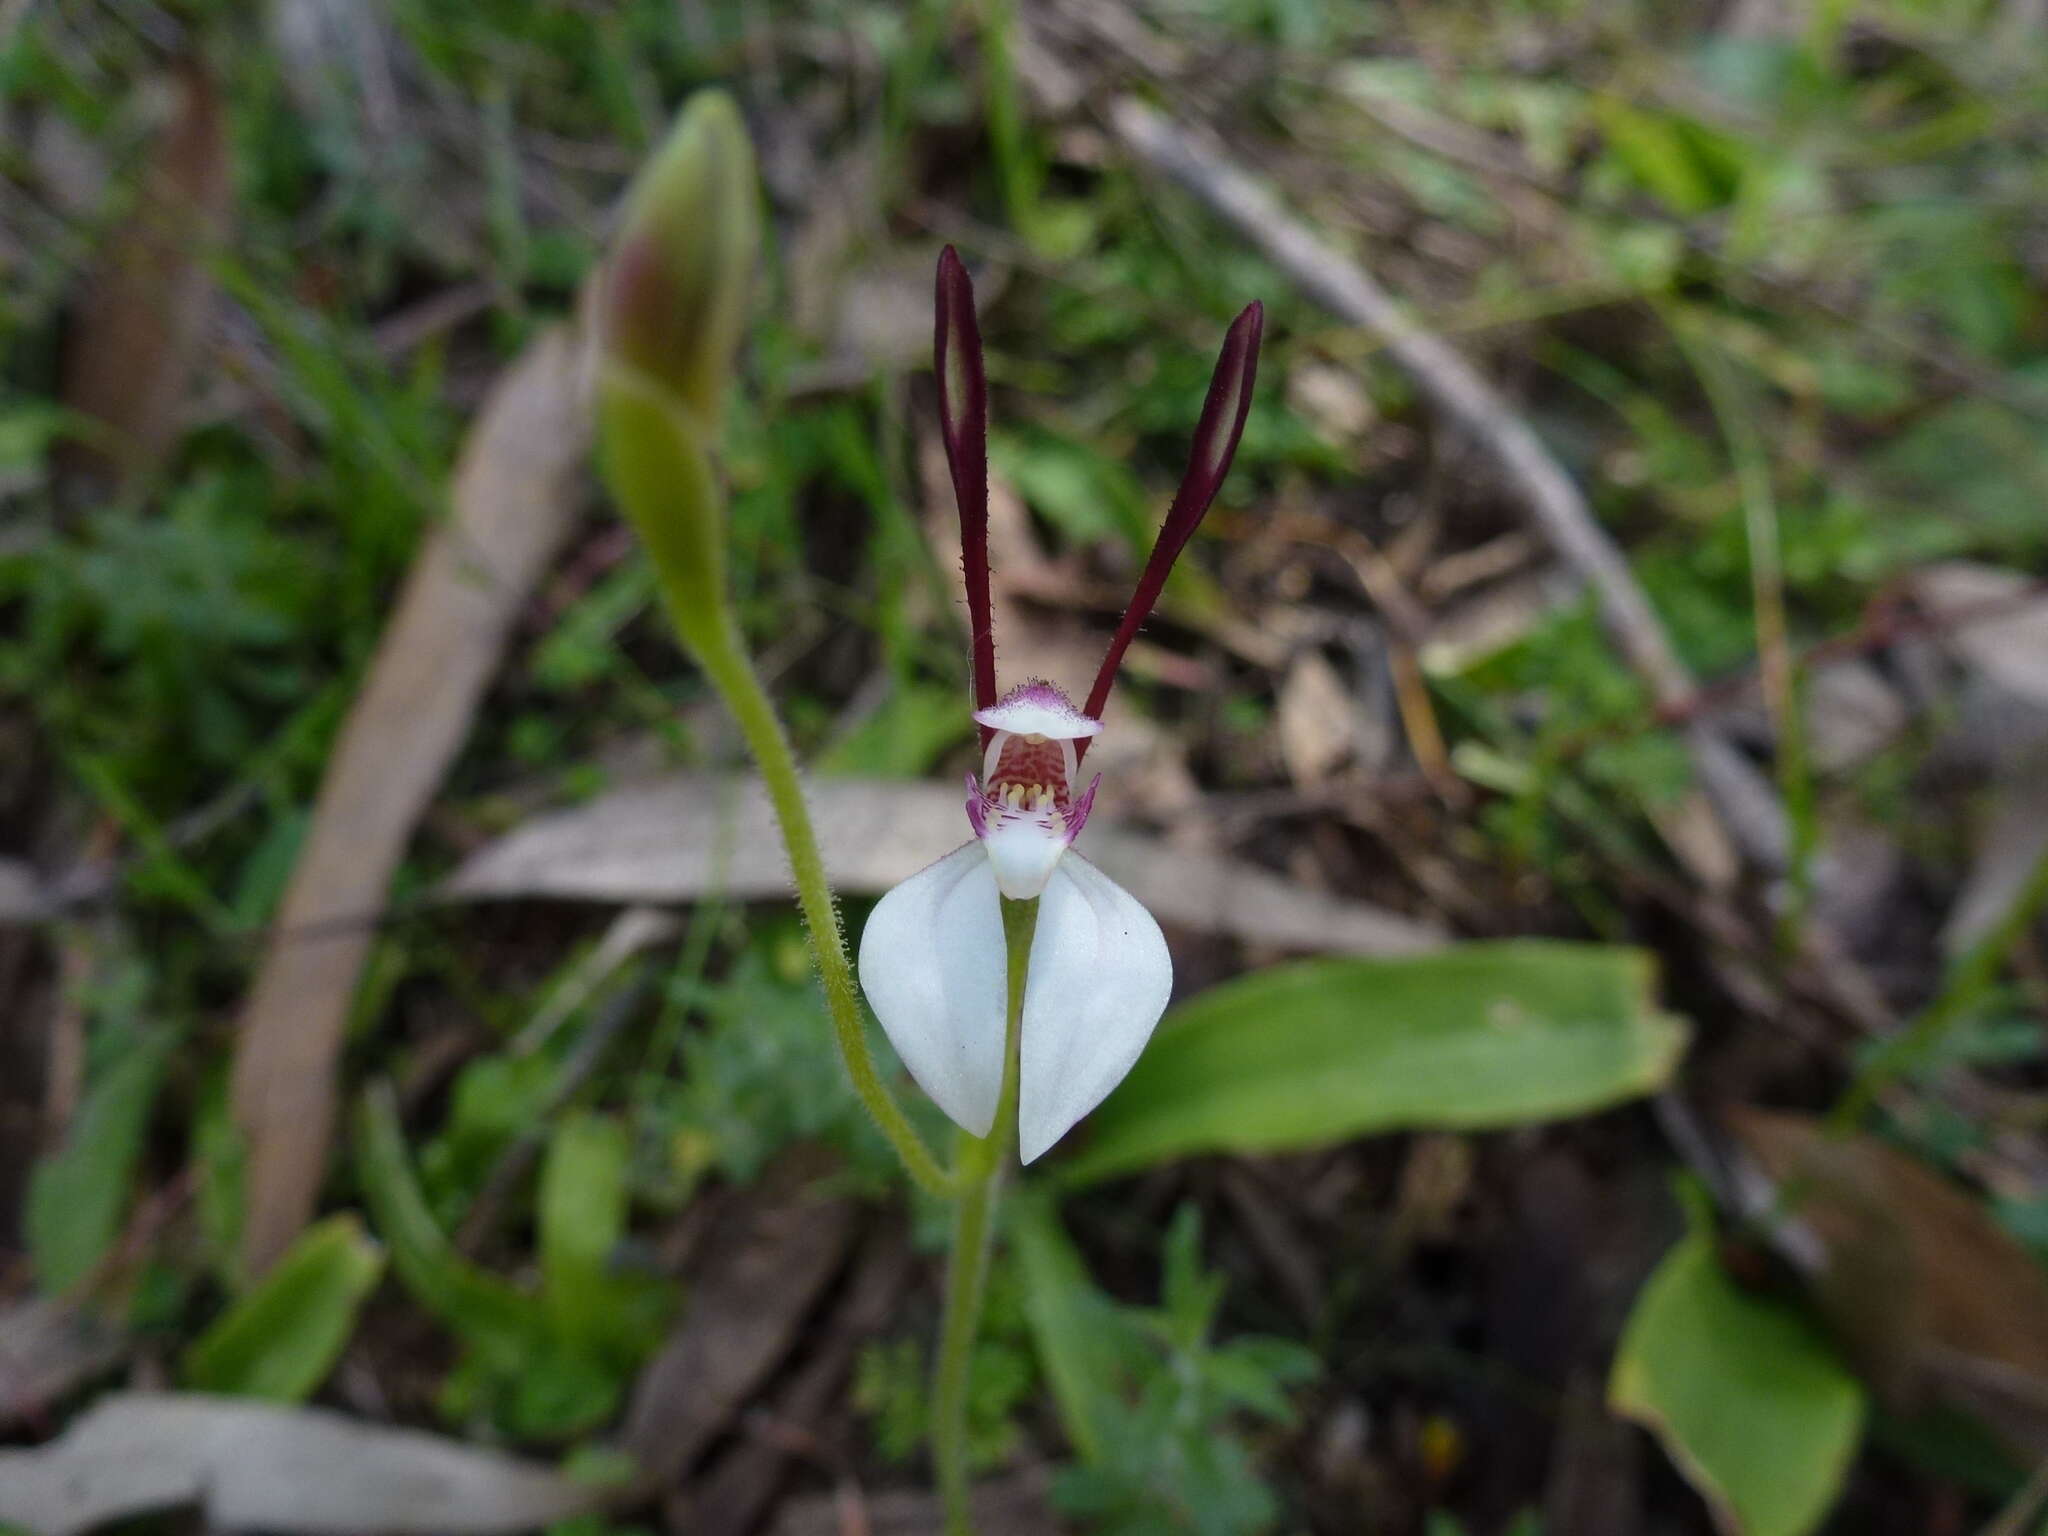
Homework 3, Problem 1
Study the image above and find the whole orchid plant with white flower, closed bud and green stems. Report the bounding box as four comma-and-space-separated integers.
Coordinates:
596, 92, 1264, 1534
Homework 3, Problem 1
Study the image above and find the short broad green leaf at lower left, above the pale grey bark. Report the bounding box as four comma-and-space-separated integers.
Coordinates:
184, 1212, 383, 1403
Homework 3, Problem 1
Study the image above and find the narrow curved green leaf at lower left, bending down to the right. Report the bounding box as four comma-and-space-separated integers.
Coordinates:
356, 1083, 549, 1366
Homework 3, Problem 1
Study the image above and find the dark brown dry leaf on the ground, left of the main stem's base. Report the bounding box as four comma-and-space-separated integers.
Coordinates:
625, 1147, 854, 1485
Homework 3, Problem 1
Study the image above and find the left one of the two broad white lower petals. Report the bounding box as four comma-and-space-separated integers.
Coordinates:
860, 840, 1008, 1137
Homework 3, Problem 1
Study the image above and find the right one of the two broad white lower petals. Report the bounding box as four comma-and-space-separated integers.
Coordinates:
1018, 852, 1174, 1163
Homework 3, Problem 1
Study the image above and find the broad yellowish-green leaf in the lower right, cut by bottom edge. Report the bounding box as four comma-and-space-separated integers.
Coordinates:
1608, 1231, 1864, 1536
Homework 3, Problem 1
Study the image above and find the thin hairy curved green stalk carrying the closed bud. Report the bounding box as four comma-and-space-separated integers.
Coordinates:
692, 618, 954, 1196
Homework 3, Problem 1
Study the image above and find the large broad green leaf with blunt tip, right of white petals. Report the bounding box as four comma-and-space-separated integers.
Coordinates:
1063, 942, 1686, 1182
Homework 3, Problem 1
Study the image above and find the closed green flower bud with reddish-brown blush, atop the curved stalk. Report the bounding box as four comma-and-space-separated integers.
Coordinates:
602, 90, 760, 432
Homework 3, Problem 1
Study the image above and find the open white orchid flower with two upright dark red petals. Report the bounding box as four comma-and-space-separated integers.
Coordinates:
860, 246, 1264, 1163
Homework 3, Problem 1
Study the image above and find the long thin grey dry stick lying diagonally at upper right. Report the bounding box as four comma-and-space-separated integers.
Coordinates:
1108, 96, 1786, 870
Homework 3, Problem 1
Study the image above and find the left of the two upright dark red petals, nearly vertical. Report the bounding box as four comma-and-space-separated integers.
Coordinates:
932, 246, 995, 724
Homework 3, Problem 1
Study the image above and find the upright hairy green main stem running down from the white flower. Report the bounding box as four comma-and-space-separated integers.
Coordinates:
932, 899, 1038, 1536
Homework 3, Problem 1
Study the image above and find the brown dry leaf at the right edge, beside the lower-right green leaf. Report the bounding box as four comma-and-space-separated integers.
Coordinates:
1729, 1108, 2048, 1454
